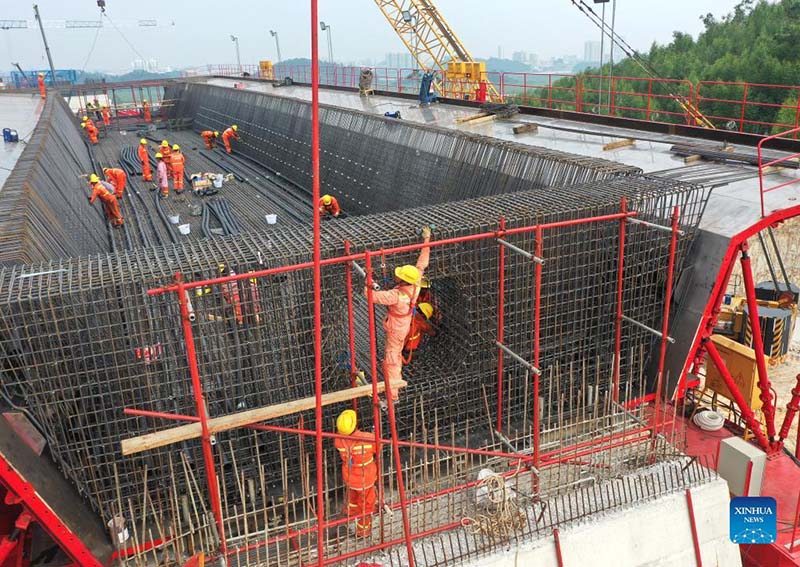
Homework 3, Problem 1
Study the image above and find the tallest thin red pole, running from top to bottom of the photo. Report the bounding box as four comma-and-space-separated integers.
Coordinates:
311, 0, 325, 567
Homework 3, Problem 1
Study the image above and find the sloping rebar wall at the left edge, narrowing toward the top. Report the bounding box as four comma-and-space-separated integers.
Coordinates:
0, 95, 109, 265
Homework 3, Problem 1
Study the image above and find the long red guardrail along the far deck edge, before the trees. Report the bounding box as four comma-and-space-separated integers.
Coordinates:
208, 64, 800, 134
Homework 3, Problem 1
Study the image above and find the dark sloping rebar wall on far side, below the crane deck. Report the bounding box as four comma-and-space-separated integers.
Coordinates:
166, 83, 640, 214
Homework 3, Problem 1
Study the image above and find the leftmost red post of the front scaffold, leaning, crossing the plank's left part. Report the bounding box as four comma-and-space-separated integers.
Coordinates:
177, 280, 228, 564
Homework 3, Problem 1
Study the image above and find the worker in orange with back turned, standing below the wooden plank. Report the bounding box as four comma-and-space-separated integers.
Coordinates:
334, 409, 378, 537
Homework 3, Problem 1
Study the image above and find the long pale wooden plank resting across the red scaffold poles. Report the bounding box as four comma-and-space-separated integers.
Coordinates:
121, 380, 408, 456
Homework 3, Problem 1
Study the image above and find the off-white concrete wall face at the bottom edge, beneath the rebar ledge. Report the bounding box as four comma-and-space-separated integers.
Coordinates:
467, 479, 742, 567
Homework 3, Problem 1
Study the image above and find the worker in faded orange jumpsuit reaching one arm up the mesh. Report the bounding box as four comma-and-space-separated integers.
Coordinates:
364, 226, 431, 401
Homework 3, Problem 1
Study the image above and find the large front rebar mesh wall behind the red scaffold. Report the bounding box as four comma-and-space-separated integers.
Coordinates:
0, 177, 706, 532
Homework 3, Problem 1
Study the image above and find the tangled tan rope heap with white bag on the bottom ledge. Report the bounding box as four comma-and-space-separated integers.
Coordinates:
461, 467, 525, 539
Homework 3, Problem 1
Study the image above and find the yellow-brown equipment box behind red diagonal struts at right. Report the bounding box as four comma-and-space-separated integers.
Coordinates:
705, 335, 768, 410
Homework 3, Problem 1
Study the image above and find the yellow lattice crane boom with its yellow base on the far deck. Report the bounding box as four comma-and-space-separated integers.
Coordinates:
375, 0, 500, 101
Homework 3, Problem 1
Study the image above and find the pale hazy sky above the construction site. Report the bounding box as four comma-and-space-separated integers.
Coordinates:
0, 0, 739, 72
